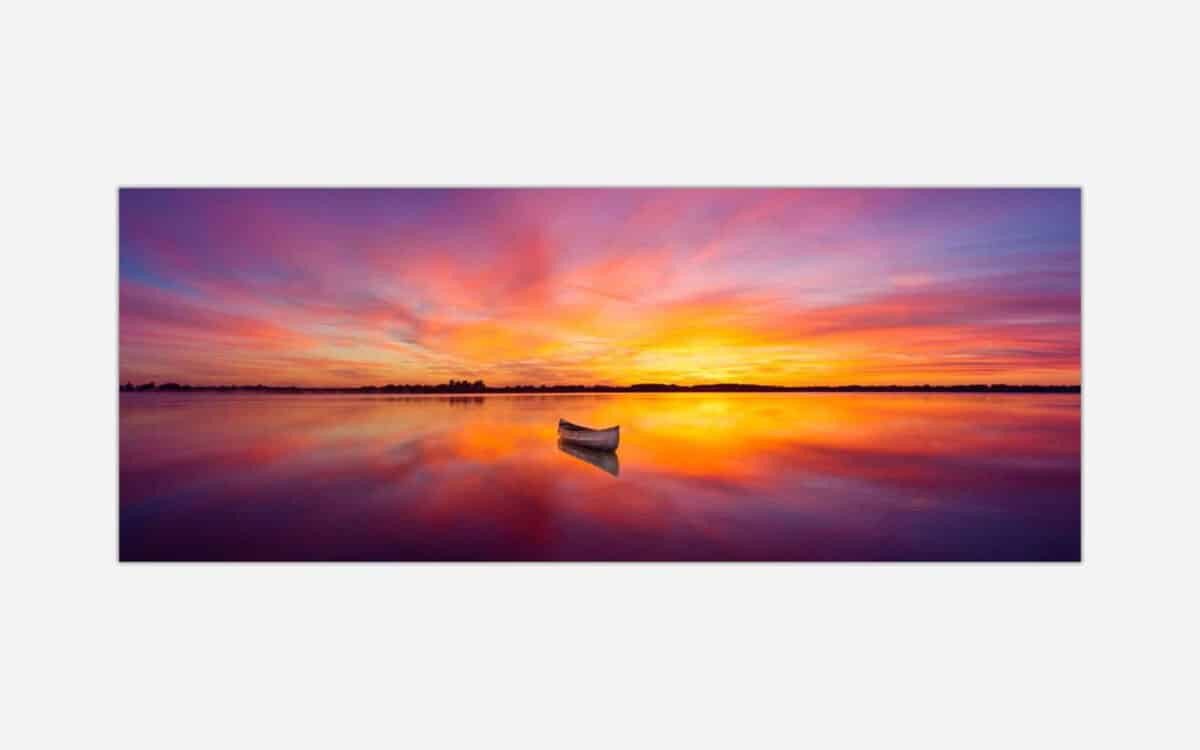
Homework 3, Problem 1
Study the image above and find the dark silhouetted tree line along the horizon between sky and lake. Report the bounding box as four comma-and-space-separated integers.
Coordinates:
120, 379, 1080, 394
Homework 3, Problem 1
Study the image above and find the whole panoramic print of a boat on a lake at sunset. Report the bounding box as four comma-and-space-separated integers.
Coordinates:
116, 188, 1081, 563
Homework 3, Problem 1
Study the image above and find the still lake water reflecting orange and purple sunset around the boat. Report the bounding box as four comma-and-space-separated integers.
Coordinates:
120, 392, 1080, 560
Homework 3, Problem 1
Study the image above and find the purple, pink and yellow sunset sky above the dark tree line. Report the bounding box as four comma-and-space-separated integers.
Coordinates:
120, 188, 1080, 386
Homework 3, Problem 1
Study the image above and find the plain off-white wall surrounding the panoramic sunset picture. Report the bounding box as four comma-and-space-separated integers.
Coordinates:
0, 0, 1198, 750
